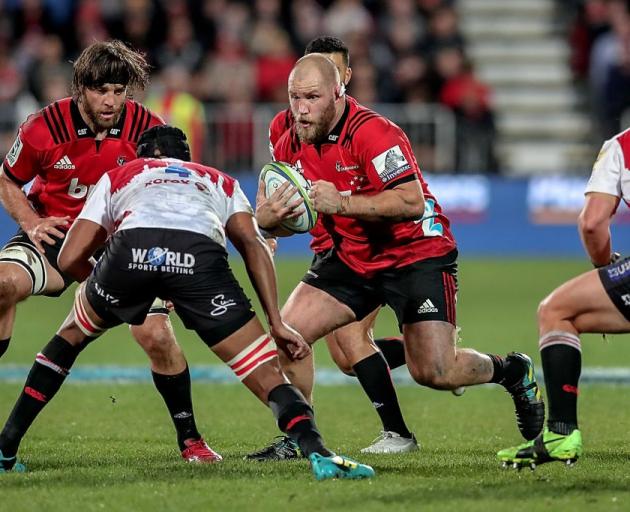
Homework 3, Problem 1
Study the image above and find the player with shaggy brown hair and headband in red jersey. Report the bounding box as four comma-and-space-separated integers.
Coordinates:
0, 41, 216, 462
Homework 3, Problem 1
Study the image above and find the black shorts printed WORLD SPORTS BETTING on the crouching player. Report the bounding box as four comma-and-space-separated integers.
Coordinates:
86, 228, 254, 345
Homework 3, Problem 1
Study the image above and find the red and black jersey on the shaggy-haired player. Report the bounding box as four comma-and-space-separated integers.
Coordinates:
3, 98, 164, 220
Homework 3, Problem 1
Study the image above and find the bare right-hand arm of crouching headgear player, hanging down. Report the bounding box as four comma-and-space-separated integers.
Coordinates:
225, 212, 310, 359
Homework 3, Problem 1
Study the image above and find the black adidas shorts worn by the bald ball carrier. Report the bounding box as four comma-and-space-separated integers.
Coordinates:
302, 249, 457, 328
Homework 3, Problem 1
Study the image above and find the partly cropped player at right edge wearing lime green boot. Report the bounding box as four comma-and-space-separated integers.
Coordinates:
497, 125, 630, 468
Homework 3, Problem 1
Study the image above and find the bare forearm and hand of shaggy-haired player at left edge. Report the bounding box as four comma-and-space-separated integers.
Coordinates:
0, 165, 70, 253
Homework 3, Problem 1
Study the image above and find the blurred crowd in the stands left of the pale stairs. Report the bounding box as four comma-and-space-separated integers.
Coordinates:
0, 0, 494, 171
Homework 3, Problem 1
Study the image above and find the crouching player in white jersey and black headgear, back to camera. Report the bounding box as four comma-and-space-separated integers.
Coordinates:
0, 126, 374, 480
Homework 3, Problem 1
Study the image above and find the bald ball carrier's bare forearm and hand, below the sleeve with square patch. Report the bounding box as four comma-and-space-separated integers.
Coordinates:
311, 180, 424, 221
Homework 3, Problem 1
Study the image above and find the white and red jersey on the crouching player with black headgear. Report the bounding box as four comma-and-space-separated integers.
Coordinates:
77, 158, 253, 247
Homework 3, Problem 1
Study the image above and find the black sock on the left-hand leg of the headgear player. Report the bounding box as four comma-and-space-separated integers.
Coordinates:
0, 336, 82, 457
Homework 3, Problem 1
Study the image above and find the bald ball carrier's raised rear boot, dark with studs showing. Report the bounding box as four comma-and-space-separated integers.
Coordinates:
505, 352, 545, 441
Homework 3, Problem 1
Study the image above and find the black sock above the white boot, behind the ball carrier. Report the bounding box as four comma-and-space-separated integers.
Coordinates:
352, 352, 411, 437
